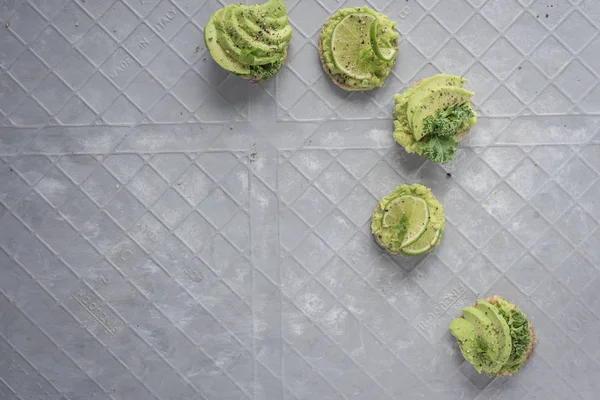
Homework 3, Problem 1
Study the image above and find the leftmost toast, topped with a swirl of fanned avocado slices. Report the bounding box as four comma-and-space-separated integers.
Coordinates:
204, 0, 292, 81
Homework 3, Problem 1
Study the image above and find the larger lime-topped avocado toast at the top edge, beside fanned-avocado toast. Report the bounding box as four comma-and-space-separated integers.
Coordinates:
318, 6, 399, 91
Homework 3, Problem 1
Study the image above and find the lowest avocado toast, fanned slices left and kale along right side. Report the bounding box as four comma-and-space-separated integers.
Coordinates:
450, 296, 536, 376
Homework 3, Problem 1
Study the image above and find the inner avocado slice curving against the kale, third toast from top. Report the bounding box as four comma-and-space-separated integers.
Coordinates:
412, 86, 475, 141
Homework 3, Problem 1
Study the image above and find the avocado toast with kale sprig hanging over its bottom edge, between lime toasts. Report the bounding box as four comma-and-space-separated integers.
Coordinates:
394, 74, 477, 164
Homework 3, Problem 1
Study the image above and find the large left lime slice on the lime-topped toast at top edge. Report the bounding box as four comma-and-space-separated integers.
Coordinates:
331, 14, 375, 79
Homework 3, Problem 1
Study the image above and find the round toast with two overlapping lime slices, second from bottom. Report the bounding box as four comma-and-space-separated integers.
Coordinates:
371, 184, 445, 256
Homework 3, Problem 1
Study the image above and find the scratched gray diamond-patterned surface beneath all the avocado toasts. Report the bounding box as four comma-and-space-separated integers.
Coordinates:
0, 0, 600, 400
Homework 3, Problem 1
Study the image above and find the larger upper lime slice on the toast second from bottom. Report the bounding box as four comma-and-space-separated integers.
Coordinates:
382, 196, 429, 248
